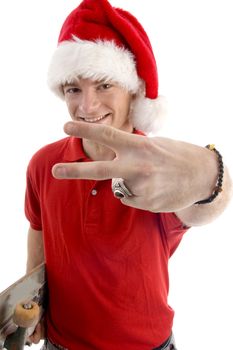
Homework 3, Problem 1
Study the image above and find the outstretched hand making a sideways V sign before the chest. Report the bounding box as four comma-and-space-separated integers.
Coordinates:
52, 122, 218, 212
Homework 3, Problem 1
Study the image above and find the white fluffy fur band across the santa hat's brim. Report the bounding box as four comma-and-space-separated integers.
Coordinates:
48, 37, 140, 98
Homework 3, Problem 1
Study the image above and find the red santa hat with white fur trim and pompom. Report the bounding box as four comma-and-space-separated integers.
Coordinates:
48, 0, 165, 133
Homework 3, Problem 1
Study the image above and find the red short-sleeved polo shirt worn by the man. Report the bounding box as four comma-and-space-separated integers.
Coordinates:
25, 137, 189, 350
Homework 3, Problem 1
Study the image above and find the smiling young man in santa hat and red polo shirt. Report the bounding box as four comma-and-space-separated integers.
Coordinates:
25, 0, 231, 350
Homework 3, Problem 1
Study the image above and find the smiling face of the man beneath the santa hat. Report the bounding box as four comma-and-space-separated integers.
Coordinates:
63, 79, 133, 132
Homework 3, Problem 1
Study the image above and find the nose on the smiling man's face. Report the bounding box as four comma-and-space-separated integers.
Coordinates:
79, 88, 100, 116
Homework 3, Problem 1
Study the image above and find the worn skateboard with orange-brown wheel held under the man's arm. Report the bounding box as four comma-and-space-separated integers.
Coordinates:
0, 263, 46, 350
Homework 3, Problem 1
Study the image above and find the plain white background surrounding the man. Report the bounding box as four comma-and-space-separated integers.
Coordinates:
0, 0, 233, 350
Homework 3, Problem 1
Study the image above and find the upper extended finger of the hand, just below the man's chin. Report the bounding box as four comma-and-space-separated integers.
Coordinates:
64, 121, 141, 153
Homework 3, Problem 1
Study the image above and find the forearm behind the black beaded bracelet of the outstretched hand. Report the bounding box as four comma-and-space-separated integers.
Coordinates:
176, 167, 233, 226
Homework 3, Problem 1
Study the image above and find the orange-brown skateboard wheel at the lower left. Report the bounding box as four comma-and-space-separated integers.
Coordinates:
13, 301, 40, 328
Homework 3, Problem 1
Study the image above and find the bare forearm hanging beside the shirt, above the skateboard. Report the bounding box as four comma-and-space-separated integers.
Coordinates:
26, 227, 44, 272
